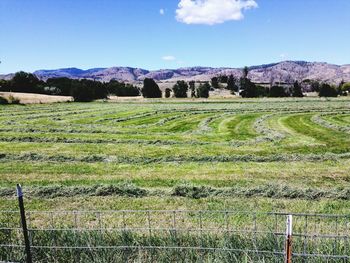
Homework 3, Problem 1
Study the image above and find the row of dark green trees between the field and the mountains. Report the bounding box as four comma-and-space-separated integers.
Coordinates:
0, 70, 350, 102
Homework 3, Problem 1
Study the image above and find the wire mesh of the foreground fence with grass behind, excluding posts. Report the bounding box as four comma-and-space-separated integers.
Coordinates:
0, 210, 350, 262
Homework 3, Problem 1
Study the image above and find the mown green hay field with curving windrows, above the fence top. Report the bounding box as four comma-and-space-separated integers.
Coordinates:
0, 98, 350, 213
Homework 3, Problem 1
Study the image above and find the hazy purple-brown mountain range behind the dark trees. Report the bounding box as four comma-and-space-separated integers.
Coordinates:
0, 61, 350, 83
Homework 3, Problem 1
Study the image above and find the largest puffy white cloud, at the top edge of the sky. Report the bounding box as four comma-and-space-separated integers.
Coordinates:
176, 0, 258, 25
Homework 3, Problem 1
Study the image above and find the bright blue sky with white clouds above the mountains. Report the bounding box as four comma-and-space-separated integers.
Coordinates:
0, 0, 350, 73
